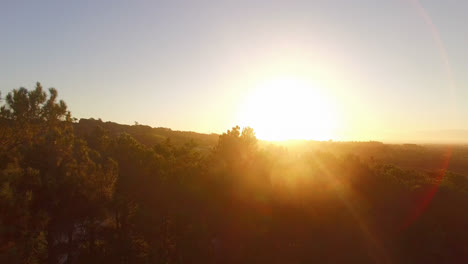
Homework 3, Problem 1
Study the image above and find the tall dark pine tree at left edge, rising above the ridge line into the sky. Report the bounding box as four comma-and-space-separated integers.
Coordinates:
0, 83, 115, 263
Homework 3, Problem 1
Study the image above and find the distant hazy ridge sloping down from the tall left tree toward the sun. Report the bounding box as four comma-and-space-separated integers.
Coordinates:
74, 118, 219, 152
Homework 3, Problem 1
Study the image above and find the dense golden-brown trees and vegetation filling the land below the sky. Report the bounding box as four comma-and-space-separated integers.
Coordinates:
0, 83, 468, 263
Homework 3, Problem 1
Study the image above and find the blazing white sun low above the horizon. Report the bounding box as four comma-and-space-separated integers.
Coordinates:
238, 78, 337, 141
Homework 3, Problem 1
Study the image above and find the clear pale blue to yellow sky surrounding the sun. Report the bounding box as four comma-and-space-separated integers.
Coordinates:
0, 0, 468, 140
